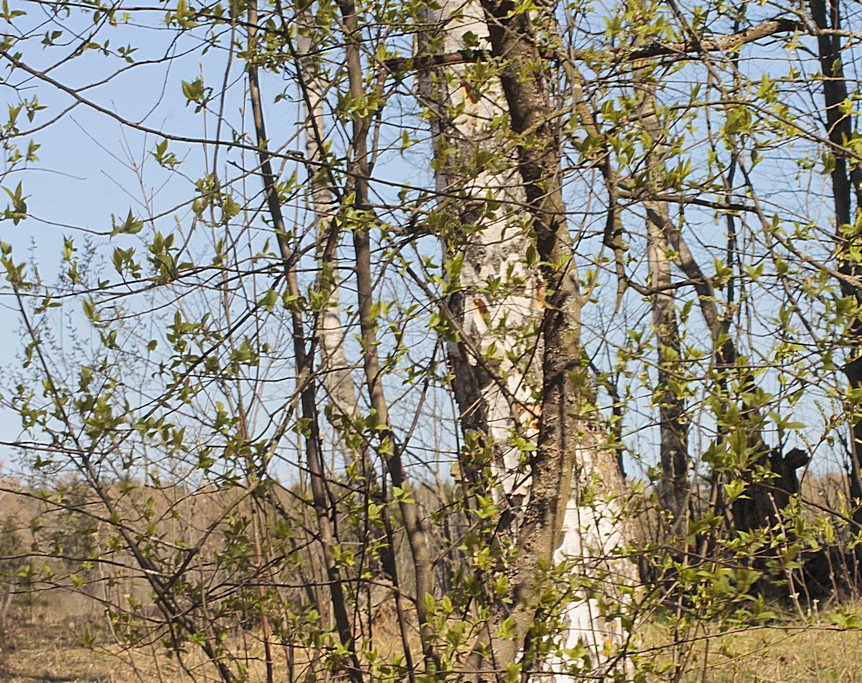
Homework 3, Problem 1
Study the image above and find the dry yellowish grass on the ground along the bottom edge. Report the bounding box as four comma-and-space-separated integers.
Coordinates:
0, 605, 862, 683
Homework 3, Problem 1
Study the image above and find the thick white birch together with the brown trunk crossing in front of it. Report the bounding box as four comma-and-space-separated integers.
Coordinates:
422, 1, 631, 681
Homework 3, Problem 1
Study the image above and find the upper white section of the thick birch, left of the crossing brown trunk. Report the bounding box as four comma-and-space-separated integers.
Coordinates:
423, 3, 541, 507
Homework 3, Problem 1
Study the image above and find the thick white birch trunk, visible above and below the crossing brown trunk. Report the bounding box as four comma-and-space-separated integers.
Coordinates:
423, 0, 632, 683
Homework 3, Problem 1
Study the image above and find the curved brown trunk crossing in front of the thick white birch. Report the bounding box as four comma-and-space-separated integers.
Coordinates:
466, 0, 636, 674
